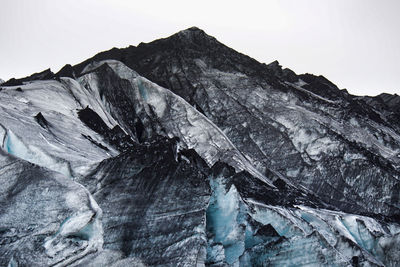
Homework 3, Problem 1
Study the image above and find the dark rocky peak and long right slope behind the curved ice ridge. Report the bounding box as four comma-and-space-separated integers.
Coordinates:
99, 28, 400, 220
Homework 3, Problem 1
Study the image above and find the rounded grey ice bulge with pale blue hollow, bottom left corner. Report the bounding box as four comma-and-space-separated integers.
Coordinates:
0, 152, 103, 266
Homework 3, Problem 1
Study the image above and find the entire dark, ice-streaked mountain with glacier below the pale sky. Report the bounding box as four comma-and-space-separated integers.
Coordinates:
0, 27, 400, 266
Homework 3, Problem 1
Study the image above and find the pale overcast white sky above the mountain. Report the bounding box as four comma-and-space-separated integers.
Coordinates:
0, 0, 400, 95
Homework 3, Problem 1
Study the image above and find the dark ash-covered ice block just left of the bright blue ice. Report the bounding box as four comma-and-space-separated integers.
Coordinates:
76, 140, 210, 266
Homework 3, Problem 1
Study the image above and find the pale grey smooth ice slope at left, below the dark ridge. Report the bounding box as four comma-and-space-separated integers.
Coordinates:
0, 78, 117, 179
